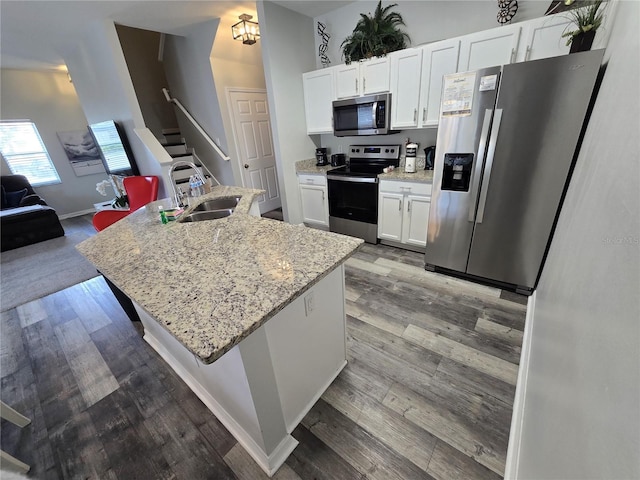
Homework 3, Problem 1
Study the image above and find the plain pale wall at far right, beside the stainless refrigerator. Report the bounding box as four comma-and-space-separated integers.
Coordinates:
510, 1, 640, 480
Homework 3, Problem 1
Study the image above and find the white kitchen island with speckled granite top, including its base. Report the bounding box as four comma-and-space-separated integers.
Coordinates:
77, 187, 362, 475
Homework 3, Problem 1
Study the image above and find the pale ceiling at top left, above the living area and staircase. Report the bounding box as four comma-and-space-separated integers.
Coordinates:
0, 0, 352, 69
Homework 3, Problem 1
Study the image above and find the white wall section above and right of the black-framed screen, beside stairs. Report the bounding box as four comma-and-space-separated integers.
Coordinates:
63, 20, 165, 197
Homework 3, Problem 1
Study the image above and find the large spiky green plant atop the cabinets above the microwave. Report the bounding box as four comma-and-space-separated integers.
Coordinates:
340, 0, 410, 64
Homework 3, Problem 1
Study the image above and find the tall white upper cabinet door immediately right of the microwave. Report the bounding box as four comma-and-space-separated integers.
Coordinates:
389, 48, 422, 128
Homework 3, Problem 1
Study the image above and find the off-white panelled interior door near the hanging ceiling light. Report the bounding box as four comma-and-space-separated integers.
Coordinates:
227, 89, 282, 213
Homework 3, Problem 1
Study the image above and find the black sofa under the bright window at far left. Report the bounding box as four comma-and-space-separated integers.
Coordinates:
0, 175, 64, 252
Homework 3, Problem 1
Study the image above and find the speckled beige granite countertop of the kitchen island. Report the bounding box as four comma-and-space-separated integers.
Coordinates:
76, 187, 363, 363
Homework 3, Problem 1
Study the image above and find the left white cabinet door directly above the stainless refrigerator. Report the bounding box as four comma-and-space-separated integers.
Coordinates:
458, 24, 521, 72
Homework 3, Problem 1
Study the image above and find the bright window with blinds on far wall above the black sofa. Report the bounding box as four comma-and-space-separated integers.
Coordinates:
0, 120, 62, 187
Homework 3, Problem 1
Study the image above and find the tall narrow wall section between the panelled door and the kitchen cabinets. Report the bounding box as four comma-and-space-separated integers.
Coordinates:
258, 2, 316, 223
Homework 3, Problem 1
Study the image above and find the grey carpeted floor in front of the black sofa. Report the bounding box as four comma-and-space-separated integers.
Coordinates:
0, 229, 98, 312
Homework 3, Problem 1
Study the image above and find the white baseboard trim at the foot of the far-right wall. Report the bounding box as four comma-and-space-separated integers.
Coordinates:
504, 291, 536, 480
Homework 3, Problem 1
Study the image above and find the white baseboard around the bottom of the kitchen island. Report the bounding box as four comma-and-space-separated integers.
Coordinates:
143, 330, 298, 477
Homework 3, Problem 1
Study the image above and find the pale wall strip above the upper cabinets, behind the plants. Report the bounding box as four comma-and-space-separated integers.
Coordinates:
313, 0, 551, 68
